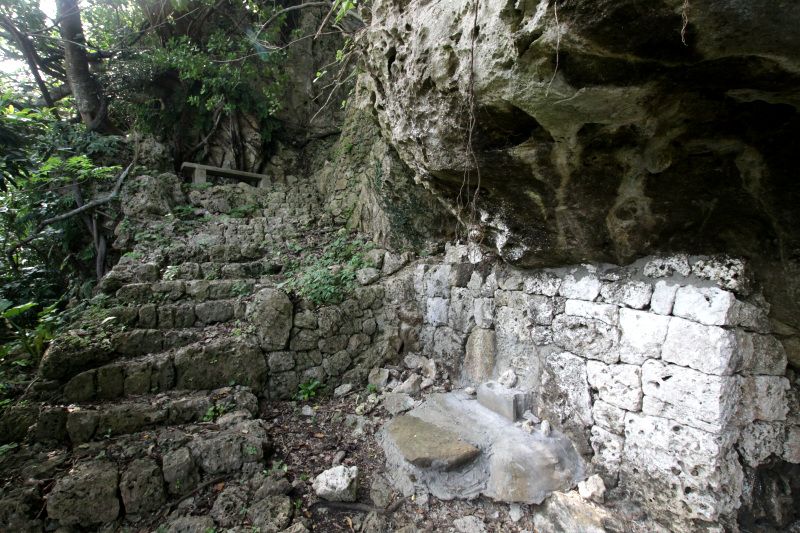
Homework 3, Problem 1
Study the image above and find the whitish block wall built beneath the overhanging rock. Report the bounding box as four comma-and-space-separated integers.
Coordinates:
400, 245, 800, 522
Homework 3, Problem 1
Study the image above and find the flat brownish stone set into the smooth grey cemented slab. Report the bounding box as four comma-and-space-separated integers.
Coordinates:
387, 415, 481, 471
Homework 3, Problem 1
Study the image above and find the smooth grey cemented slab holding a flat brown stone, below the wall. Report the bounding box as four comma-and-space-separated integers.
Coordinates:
378, 391, 585, 504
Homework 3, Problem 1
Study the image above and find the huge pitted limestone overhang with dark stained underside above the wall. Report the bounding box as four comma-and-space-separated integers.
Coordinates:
366, 0, 800, 332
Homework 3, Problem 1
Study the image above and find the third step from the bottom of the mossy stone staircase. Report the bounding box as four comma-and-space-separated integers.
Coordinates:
64, 336, 267, 402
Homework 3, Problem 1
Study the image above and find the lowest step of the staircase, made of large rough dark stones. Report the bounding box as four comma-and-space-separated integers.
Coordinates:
0, 404, 278, 531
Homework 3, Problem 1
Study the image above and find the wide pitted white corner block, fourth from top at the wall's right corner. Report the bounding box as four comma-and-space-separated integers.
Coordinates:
642, 360, 747, 432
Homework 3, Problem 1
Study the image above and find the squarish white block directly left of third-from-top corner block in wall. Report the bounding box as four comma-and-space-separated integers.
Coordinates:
619, 309, 670, 365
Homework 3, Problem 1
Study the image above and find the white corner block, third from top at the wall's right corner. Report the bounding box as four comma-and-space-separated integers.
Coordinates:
661, 317, 741, 375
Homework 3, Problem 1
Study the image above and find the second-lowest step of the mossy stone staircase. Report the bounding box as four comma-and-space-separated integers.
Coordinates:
32, 387, 258, 446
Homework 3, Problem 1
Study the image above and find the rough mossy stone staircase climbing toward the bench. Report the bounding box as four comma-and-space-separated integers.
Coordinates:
0, 175, 346, 532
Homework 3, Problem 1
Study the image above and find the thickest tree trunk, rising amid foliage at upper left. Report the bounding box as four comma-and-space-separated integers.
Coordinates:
56, 0, 112, 131
